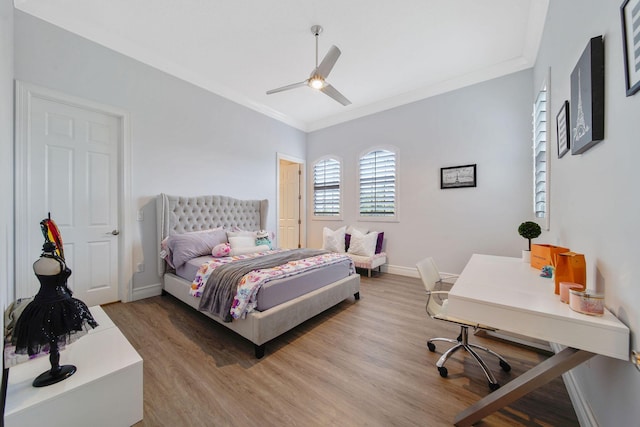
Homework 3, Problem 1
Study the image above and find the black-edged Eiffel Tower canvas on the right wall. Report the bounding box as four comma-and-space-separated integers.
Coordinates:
570, 36, 604, 154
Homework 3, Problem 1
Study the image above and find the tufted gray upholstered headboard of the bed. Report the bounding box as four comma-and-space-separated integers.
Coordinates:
156, 193, 269, 276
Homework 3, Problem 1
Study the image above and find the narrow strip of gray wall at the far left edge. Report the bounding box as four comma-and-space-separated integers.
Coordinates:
0, 0, 13, 330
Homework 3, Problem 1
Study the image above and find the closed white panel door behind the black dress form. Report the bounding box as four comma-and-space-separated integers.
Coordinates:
24, 97, 120, 306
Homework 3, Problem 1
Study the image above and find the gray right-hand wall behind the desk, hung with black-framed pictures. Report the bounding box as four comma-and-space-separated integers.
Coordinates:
534, 0, 640, 426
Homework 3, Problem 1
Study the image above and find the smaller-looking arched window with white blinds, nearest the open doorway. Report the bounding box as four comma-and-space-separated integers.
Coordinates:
313, 158, 340, 216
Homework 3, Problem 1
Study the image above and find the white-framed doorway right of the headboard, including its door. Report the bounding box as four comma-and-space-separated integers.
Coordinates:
278, 154, 306, 249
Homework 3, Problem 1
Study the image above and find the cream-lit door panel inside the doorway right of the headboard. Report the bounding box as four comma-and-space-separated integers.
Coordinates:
278, 161, 301, 249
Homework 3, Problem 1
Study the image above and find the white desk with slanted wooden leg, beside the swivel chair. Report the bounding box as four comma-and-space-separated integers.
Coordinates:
448, 254, 629, 426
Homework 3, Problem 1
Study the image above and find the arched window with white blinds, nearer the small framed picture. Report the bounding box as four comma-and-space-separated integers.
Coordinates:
360, 150, 396, 217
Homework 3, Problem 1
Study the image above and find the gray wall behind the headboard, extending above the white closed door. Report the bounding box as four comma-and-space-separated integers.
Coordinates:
15, 11, 306, 298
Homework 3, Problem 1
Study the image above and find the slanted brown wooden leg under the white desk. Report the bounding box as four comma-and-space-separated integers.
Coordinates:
454, 347, 596, 427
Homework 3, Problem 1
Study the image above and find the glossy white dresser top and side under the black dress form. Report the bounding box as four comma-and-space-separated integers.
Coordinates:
4, 306, 143, 427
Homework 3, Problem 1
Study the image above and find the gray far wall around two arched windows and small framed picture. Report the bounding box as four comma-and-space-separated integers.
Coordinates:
307, 70, 533, 274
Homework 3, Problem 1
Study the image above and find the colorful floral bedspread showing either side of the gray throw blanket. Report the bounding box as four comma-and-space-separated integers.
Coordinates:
189, 249, 355, 319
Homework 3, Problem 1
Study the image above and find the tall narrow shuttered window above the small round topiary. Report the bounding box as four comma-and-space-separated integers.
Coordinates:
533, 86, 547, 218
